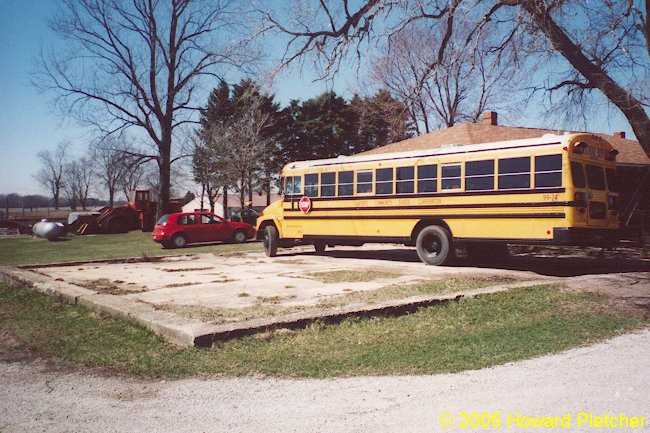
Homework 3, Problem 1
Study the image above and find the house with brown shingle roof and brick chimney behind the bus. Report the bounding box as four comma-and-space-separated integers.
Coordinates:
358, 111, 650, 243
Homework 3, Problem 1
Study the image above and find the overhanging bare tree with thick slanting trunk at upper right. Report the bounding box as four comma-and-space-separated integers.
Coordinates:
262, 0, 650, 155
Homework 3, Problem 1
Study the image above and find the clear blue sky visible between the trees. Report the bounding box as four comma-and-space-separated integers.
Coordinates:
0, 0, 631, 194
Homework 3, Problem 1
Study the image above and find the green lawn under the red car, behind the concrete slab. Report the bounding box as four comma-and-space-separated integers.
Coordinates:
0, 231, 262, 265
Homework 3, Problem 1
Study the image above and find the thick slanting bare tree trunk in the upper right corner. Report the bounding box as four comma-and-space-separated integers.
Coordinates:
521, 0, 650, 156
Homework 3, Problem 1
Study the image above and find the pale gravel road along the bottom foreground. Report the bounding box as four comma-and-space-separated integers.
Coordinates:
0, 329, 650, 433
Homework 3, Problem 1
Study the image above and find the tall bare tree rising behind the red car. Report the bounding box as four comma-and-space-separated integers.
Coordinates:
35, 0, 250, 212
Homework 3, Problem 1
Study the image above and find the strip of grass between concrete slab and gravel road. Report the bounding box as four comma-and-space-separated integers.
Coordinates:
0, 285, 649, 377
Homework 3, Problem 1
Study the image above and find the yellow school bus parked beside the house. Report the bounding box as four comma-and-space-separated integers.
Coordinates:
257, 134, 619, 265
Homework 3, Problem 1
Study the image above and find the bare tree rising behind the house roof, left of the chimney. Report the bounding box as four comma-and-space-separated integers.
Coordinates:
371, 25, 522, 134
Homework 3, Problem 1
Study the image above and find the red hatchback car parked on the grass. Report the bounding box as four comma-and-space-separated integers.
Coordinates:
151, 212, 255, 248
